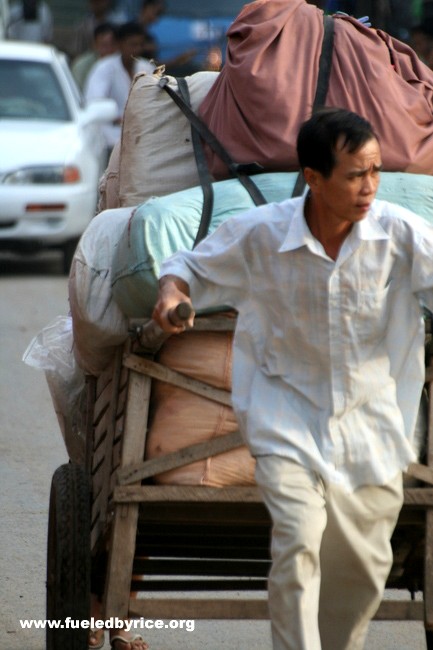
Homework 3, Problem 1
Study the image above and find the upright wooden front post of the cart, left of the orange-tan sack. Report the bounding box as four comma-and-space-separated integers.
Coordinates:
103, 371, 151, 618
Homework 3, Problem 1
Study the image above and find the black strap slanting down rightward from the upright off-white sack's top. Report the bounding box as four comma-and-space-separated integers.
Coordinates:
159, 77, 267, 205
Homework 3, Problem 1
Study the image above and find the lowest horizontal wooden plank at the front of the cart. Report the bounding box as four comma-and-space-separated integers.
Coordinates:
129, 596, 269, 620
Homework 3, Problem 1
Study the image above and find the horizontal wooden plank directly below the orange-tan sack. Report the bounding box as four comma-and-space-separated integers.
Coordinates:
113, 485, 262, 503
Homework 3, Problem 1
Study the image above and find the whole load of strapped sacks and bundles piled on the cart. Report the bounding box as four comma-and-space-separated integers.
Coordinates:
69, 0, 433, 486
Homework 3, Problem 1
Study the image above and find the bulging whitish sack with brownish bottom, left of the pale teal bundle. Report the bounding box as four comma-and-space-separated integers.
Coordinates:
69, 208, 133, 375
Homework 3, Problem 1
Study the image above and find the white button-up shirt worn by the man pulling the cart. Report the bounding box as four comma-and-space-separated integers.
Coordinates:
160, 197, 433, 489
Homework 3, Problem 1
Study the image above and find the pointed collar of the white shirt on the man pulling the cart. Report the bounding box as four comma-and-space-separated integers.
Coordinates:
278, 195, 389, 253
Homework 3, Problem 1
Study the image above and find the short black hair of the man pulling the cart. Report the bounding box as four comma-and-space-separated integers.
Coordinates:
296, 108, 378, 178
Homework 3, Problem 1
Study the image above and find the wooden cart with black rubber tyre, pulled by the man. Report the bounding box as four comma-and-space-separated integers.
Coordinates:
47, 317, 433, 650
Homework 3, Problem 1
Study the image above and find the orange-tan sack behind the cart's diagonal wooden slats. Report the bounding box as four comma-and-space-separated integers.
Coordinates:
146, 324, 255, 487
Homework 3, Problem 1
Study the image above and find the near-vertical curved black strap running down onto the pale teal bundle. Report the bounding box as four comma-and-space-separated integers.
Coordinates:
177, 77, 214, 248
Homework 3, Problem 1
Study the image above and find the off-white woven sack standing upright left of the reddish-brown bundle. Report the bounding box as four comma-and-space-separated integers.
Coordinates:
119, 71, 218, 207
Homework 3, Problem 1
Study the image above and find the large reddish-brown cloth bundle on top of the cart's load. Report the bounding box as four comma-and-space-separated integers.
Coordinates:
200, 0, 433, 178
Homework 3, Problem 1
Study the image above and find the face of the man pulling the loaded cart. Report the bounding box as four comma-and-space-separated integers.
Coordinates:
310, 138, 382, 226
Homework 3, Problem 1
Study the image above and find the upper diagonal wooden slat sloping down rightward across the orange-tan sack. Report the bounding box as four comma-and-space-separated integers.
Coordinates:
123, 354, 232, 406
